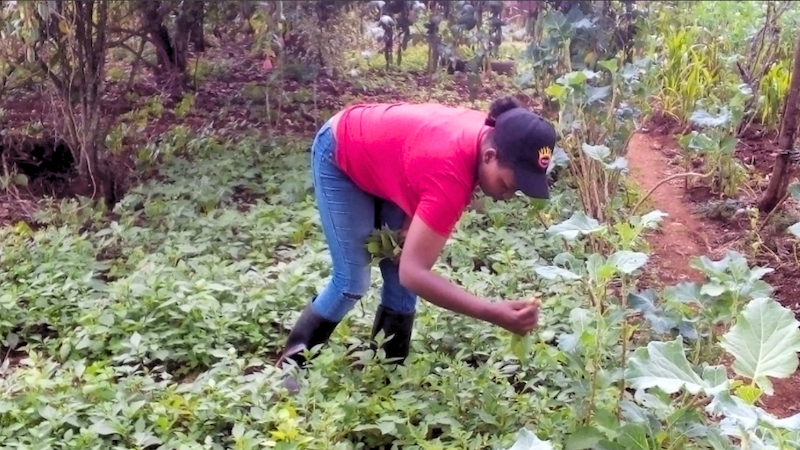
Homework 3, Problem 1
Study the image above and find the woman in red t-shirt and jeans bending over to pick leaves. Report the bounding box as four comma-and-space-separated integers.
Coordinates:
278, 97, 556, 391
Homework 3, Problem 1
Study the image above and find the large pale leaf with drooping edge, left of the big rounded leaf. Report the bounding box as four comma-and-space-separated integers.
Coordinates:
625, 336, 728, 394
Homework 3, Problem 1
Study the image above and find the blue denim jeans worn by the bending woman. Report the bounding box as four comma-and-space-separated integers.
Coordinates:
311, 122, 417, 322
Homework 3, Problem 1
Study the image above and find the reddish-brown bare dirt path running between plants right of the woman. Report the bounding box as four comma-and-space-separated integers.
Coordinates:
627, 133, 711, 284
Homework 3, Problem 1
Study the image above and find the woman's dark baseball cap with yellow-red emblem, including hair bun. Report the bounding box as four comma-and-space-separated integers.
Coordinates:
493, 108, 557, 200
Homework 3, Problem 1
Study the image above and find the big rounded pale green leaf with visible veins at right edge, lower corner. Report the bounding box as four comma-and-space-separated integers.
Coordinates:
720, 298, 800, 395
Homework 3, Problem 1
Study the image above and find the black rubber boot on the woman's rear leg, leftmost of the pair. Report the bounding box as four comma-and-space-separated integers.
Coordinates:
275, 300, 339, 394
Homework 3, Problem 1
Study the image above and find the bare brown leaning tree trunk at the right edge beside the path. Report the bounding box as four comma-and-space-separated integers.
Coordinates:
758, 29, 800, 213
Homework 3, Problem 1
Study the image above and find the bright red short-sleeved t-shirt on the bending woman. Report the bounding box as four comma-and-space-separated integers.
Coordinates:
336, 103, 488, 236
